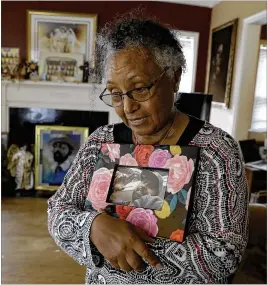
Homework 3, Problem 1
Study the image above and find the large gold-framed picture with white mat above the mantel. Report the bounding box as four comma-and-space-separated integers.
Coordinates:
27, 10, 97, 64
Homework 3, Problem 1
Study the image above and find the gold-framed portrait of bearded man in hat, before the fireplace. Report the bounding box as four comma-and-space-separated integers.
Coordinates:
35, 125, 88, 190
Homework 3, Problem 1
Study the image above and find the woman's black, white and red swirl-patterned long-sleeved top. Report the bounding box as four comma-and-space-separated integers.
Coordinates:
48, 117, 248, 284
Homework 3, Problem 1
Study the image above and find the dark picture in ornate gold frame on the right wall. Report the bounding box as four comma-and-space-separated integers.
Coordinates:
206, 19, 238, 108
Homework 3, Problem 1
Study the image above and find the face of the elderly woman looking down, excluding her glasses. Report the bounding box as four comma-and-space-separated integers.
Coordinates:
107, 48, 176, 136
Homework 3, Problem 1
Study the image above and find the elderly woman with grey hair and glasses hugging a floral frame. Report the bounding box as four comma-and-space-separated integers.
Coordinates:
48, 13, 248, 284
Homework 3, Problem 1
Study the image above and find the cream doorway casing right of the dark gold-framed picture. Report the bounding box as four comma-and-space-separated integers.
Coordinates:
232, 10, 267, 140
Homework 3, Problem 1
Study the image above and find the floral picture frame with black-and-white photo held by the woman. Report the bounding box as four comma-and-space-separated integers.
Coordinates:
85, 143, 199, 242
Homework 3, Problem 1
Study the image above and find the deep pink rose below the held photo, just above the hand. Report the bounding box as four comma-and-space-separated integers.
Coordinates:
126, 208, 159, 237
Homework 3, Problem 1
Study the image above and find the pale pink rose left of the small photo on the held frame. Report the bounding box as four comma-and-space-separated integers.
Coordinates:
87, 167, 113, 210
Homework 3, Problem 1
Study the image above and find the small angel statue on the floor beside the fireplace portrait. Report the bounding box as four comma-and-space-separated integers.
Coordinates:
7, 144, 33, 190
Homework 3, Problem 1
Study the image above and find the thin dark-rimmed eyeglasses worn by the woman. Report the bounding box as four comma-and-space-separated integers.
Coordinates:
99, 68, 168, 107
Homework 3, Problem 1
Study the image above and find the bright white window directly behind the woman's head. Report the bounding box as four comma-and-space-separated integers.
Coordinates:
176, 31, 199, 92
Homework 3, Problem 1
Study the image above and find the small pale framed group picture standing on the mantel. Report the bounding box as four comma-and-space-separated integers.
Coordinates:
39, 51, 84, 82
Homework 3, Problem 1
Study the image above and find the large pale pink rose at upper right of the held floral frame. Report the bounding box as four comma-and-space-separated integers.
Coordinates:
163, 154, 194, 194
